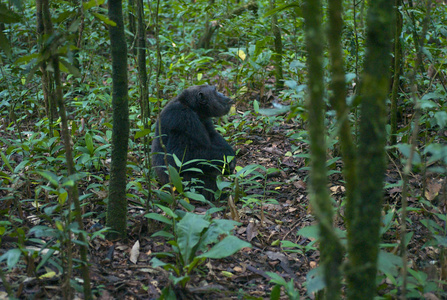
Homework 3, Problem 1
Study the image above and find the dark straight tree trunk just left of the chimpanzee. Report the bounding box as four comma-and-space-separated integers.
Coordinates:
107, 0, 129, 239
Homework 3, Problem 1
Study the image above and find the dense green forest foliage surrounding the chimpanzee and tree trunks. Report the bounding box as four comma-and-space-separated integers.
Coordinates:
0, 0, 447, 299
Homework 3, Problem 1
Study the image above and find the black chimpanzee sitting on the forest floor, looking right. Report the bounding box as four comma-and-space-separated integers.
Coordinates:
151, 85, 235, 200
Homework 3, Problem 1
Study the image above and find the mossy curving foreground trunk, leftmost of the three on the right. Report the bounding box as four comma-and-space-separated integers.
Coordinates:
303, 0, 343, 299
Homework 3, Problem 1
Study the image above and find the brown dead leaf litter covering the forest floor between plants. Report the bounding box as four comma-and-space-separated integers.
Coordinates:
0, 99, 446, 299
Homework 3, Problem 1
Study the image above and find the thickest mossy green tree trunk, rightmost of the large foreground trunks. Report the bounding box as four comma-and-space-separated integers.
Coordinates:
347, 0, 394, 300
